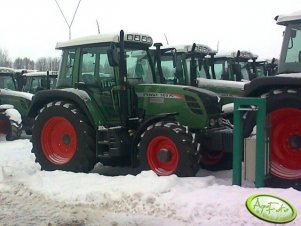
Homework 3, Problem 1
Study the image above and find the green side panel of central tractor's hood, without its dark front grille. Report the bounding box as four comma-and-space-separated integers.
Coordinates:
135, 84, 216, 129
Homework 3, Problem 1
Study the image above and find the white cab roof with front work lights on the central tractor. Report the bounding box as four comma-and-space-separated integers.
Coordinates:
55, 33, 153, 49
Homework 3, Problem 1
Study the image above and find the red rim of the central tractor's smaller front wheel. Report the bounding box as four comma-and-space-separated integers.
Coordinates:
147, 136, 179, 176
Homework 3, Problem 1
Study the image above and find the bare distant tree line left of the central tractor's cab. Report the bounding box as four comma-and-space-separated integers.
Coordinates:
0, 48, 60, 71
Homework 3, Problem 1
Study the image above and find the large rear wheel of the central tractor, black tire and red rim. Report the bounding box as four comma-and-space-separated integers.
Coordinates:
32, 101, 96, 172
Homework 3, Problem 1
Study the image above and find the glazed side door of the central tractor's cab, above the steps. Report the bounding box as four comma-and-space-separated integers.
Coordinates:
78, 46, 120, 126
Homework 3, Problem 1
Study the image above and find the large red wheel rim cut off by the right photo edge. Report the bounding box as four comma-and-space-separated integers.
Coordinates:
271, 108, 301, 179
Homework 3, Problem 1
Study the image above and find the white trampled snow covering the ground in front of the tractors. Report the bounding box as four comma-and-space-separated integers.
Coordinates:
0, 136, 301, 226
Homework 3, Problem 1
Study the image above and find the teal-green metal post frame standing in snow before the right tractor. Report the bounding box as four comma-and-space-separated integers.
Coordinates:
232, 98, 266, 187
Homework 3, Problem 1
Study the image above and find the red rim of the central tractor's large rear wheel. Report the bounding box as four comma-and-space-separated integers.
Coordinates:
41, 117, 77, 165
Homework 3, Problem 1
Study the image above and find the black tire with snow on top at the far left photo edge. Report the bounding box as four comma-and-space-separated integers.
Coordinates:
0, 113, 22, 141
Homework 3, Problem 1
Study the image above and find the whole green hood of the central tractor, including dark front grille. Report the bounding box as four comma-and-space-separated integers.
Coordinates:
134, 84, 221, 128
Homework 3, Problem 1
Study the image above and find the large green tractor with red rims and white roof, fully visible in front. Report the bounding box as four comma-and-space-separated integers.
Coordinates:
29, 31, 233, 176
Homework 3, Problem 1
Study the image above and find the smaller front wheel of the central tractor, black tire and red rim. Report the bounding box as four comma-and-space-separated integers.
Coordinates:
138, 122, 199, 177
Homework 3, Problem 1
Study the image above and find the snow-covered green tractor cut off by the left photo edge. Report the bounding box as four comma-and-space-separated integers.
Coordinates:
0, 67, 32, 140
